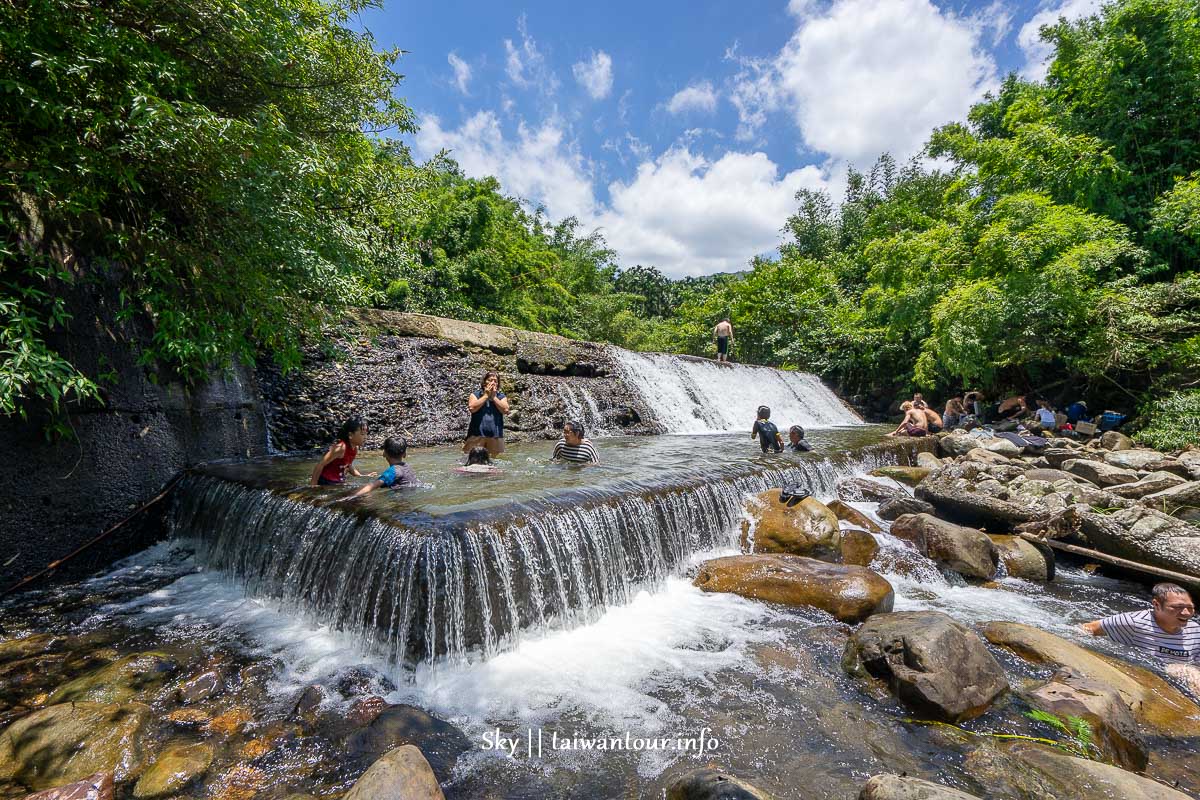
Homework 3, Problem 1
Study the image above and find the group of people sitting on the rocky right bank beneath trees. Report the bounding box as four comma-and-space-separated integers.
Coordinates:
888, 391, 1126, 437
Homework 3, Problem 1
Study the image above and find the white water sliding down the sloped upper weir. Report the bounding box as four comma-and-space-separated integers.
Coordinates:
614, 349, 863, 433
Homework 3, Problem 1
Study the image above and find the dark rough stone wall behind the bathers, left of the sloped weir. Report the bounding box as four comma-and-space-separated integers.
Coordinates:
259, 311, 660, 452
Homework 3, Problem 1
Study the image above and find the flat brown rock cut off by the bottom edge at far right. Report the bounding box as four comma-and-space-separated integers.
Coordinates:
967, 741, 1189, 800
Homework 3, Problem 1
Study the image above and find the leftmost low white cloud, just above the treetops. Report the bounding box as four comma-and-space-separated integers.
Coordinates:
415, 112, 596, 219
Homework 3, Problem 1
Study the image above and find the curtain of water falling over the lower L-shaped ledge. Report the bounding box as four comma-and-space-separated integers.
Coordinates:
172, 449, 895, 663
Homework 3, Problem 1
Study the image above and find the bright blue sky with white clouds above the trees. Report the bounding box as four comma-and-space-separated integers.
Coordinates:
360, 0, 1099, 277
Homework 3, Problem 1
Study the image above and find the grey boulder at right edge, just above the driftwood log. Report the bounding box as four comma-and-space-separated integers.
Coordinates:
1079, 506, 1200, 583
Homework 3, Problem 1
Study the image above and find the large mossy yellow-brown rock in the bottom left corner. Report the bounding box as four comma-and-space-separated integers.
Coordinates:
0, 702, 150, 790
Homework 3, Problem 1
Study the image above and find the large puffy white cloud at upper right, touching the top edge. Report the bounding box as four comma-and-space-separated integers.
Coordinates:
774, 0, 996, 163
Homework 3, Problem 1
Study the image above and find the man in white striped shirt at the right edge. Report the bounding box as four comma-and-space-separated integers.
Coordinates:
1082, 583, 1200, 698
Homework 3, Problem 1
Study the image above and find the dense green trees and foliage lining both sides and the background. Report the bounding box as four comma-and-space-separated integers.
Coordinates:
0, 0, 1200, 441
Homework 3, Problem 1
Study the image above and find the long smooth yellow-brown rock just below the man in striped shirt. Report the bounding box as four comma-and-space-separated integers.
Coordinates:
983, 622, 1200, 738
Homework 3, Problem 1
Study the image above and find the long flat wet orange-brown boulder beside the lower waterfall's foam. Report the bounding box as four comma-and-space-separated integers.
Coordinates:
692, 553, 895, 622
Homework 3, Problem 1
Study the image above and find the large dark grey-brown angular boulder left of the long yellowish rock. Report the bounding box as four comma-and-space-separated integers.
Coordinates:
842, 612, 1008, 722
